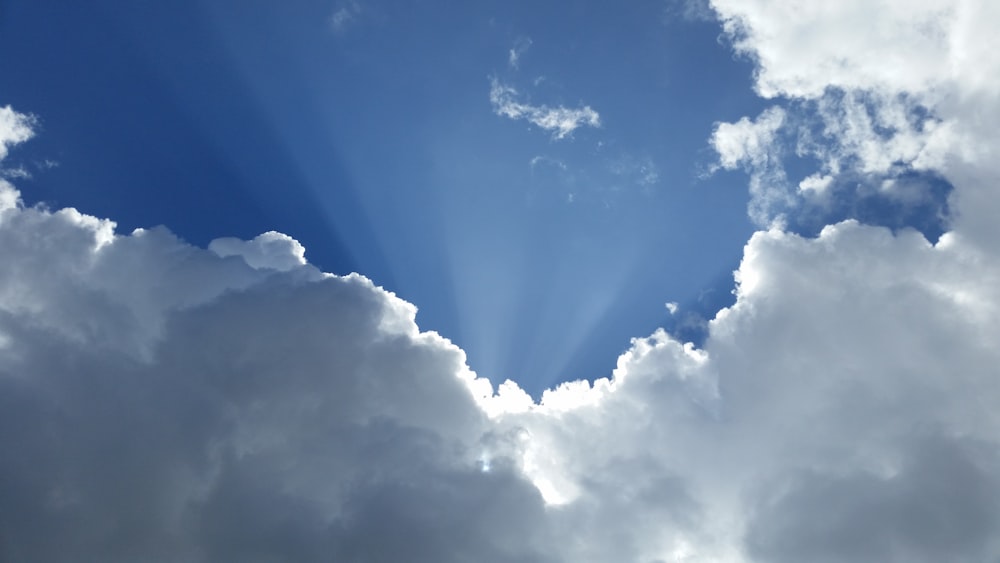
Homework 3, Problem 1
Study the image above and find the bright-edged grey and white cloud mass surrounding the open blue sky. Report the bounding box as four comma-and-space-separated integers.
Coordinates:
0, 1, 1000, 563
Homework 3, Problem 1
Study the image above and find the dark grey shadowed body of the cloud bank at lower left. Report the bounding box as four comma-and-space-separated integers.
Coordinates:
0, 218, 543, 561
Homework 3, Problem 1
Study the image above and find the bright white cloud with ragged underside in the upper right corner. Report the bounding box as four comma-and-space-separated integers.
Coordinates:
713, 0, 1000, 240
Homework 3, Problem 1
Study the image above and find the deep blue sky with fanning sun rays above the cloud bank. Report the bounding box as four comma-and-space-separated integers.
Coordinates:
0, 0, 766, 393
